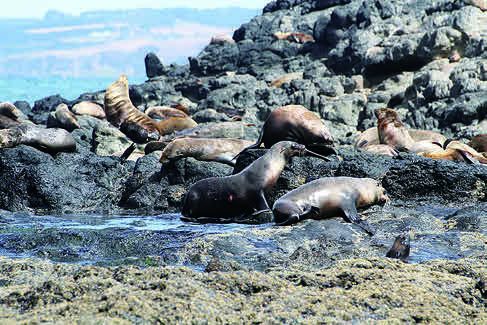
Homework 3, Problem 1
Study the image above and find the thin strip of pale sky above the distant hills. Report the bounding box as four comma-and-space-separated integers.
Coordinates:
0, 0, 270, 18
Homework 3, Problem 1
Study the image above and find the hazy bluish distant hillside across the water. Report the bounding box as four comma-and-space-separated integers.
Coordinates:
0, 8, 259, 78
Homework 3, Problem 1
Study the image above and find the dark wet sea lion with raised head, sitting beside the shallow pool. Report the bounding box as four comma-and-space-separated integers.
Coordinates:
181, 141, 328, 222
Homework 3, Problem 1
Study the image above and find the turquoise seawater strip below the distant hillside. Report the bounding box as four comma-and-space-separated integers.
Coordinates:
0, 76, 147, 105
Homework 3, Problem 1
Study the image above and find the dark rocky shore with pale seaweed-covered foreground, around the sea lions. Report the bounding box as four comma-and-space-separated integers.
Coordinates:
0, 0, 487, 323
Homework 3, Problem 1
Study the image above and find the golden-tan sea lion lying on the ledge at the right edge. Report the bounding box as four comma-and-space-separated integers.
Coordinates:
418, 141, 487, 164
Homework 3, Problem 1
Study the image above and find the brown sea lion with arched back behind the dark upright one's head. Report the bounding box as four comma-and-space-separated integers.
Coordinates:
238, 105, 336, 154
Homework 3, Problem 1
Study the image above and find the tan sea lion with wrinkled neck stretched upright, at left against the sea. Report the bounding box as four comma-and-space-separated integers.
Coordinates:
105, 75, 197, 143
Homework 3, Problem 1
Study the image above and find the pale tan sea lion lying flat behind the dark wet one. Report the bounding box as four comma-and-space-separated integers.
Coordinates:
160, 138, 252, 166
